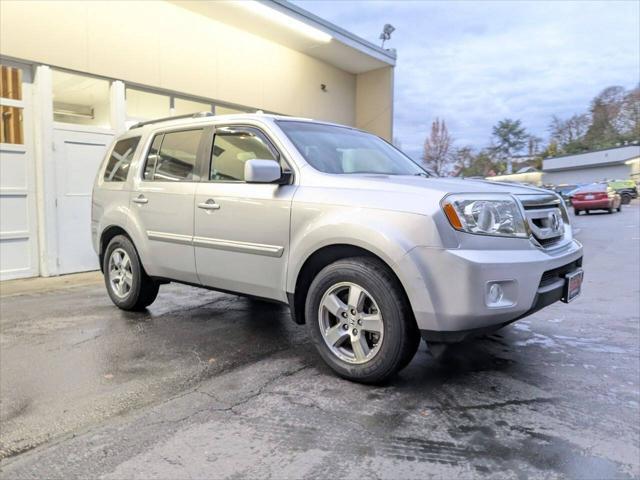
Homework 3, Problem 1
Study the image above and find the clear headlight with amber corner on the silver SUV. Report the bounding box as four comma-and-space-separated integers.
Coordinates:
442, 194, 529, 238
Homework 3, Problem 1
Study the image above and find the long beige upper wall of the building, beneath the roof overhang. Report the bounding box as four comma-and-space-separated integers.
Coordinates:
0, 0, 360, 127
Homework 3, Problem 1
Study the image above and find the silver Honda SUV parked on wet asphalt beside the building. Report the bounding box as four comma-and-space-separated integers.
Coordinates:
91, 114, 582, 382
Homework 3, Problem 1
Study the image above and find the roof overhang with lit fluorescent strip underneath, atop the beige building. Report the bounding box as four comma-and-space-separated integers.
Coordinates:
169, 0, 396, 74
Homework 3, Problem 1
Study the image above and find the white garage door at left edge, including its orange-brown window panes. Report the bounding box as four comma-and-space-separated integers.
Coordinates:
0, 62, 39, 280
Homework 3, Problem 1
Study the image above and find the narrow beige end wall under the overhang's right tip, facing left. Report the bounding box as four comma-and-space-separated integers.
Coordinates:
356, 67, 393, 142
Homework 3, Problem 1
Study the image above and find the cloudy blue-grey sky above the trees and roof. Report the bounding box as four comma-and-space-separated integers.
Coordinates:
294, 0, 640, 158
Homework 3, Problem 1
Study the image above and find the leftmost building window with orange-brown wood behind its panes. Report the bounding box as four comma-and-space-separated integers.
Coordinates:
0, 65, 24, 145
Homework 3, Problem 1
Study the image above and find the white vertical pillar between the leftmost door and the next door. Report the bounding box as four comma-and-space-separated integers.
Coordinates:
33, 65, 58, 277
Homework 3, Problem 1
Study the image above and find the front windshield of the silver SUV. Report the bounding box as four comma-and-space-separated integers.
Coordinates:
278, 120, 430, 176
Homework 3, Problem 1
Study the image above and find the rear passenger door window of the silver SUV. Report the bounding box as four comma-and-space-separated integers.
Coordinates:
144, 129, 203, 182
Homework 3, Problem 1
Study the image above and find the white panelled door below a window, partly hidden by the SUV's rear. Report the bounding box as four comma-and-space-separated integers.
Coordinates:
53, 123, 113, 274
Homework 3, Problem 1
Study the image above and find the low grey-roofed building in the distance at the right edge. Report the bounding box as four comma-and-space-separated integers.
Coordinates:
542, 145, 640, 185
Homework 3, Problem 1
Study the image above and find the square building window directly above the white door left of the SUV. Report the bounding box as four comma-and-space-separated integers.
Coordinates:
51, 70, 111, 128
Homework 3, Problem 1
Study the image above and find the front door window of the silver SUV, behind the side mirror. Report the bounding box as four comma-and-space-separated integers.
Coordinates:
209, 127, 278, 182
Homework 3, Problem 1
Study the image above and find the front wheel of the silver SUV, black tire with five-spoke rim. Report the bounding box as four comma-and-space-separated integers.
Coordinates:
305, 257, 420, 383
